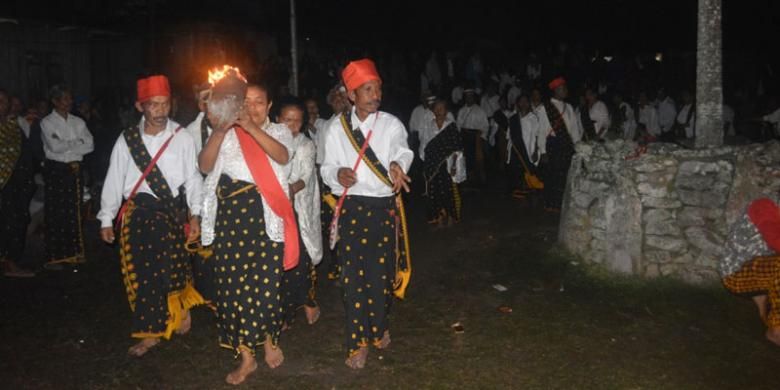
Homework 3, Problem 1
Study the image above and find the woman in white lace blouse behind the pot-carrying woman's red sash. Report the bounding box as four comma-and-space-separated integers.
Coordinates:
276, 100, 322, 329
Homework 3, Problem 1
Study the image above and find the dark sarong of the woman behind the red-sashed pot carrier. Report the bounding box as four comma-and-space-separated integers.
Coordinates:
281, 216, 317, 325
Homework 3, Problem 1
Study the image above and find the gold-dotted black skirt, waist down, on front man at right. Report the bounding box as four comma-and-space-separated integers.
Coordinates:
338, 195, 396, 355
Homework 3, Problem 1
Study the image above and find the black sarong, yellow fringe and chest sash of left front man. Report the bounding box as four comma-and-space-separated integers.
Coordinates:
119, 128, 204, 339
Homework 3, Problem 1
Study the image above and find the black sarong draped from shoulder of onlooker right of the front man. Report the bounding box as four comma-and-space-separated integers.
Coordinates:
423, 123, 463, 221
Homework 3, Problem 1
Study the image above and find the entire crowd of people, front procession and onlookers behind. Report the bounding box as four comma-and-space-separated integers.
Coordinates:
0, 45, 780, 384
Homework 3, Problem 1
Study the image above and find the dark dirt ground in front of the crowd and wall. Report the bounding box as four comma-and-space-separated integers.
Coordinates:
0, 183, 780, 389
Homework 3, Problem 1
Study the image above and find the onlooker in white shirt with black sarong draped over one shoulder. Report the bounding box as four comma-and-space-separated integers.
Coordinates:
420, 100, 465, 226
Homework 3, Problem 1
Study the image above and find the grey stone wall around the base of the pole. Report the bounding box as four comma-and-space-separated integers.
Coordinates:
559, 140, 780, 283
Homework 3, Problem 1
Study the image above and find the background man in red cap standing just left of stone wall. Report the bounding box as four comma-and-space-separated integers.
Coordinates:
536, 77, 582, 211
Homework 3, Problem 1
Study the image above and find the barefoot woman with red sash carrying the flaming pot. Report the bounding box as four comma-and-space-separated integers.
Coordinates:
198, 80, 300, 385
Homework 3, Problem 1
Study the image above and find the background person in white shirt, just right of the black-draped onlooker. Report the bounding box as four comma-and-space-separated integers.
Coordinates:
457, 89, 490, 184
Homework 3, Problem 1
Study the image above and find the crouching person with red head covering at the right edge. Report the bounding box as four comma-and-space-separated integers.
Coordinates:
720, 198, 780, 345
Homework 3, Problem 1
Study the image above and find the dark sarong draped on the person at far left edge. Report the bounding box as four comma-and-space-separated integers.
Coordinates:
0, 120, 35, 263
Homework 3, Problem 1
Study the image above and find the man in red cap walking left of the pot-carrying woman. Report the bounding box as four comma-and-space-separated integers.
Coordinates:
97, 75, 203, 356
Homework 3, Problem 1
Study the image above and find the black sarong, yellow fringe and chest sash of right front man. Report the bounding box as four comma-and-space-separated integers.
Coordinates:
337, 114, 412, 356
